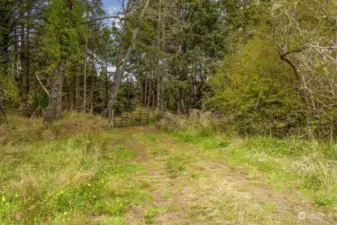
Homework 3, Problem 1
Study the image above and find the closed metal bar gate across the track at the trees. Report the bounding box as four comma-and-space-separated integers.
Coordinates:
114, 110, 150, 127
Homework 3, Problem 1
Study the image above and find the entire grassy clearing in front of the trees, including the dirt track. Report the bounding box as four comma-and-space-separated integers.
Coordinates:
0, 114, 337, 225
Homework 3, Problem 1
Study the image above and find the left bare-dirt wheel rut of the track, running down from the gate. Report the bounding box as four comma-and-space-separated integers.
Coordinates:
125, 127, 188, 224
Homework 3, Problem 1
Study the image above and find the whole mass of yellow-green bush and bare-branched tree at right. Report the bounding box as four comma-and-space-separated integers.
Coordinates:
204, 1, 336, 141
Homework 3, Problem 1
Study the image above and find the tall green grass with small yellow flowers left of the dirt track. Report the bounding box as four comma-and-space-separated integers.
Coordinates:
0, 116, 149, 224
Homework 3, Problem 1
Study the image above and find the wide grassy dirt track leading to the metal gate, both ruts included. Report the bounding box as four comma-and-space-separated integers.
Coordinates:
118, 127, 337, 225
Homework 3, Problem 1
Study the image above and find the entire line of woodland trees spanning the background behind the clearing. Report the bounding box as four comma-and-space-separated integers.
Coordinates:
0, 0, 337, 139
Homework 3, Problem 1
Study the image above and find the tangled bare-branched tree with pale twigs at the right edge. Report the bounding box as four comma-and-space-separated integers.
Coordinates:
271, 1, 337, 137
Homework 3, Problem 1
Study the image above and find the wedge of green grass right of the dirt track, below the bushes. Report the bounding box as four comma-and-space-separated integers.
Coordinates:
171, 131, 337, 208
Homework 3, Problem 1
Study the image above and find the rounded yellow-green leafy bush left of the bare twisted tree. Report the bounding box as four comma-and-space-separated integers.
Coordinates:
205, 33, 301, 134
